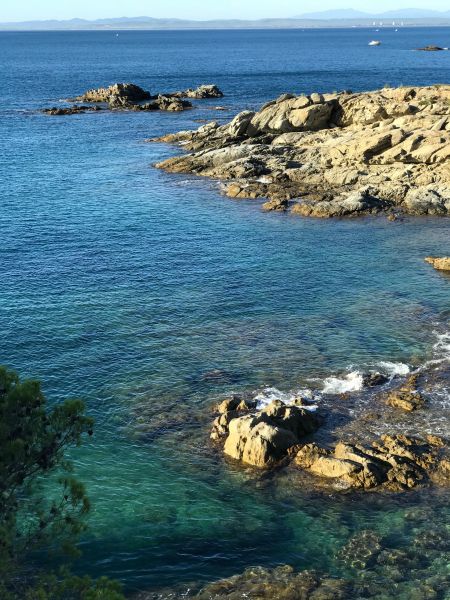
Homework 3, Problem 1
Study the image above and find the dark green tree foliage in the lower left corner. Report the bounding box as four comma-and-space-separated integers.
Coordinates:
0, 367, 123, 600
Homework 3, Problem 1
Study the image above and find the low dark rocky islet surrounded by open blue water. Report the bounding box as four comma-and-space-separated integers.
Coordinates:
43, 83, 223, 116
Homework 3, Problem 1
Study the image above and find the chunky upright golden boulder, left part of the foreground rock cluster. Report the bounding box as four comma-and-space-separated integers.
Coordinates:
211, 400, 320, 467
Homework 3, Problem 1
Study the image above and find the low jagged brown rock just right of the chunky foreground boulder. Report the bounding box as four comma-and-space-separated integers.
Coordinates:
295, 435, 450, 491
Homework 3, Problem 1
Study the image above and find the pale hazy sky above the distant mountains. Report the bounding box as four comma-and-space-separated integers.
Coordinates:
0, 0, 449, 22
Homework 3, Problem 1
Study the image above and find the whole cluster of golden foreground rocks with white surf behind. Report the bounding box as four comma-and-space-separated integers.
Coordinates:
211, 373, 450, 492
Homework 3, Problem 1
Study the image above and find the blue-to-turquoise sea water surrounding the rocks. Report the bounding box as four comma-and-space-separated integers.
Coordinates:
0, 29, 450, 589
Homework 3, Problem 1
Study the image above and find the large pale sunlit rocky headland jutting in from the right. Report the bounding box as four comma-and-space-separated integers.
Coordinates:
151, 85, 450, 219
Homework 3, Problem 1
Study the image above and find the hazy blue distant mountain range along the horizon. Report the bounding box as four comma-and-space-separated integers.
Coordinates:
0, 8, 450, 31
